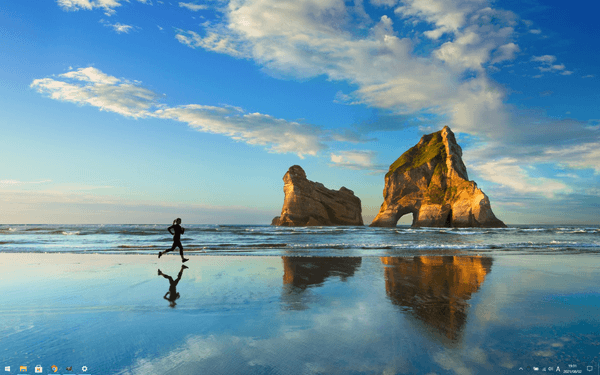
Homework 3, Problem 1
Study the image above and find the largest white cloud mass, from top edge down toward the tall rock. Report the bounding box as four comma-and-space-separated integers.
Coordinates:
176, 0, 519, 140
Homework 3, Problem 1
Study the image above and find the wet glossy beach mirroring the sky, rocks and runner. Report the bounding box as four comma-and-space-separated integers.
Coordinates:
0, 253, 600, 374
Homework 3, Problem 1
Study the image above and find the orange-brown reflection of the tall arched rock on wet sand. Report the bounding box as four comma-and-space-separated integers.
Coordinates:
381, 256, 492, 341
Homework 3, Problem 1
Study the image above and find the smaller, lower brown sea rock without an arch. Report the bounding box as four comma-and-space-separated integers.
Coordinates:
271, 165, 363, 227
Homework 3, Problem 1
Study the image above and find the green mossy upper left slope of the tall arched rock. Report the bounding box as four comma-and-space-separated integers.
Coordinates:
385, 131, 446, 177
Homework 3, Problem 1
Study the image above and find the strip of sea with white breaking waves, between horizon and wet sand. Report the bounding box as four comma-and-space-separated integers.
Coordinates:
0, 224, 600, 256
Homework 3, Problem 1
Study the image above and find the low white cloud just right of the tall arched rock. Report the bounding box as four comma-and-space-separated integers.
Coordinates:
470, 158, 572, 198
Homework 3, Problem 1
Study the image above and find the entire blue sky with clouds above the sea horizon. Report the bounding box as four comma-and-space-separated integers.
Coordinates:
0, 0, 600, 225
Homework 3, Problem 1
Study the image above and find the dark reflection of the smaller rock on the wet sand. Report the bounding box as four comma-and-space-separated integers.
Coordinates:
281, 257, 362, 310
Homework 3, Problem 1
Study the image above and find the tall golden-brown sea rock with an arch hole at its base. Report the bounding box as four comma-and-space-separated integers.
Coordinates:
371, 126, 506, 227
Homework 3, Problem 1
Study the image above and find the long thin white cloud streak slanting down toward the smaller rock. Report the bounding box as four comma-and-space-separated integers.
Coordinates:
31, 67, 330, 157
